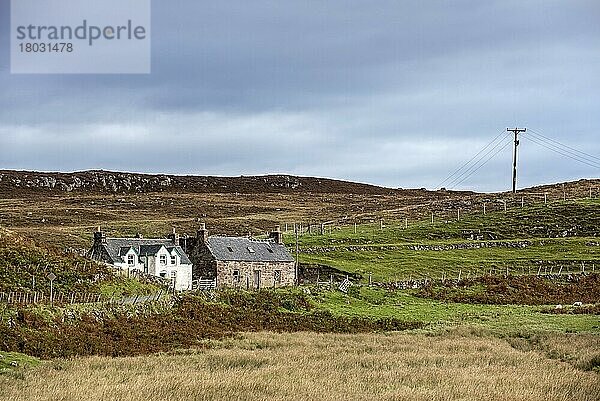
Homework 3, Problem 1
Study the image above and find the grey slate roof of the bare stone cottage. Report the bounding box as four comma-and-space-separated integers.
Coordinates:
207, 235, 294, 262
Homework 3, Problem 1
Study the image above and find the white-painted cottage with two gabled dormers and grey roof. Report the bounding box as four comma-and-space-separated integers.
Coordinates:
88, 229, 192, 291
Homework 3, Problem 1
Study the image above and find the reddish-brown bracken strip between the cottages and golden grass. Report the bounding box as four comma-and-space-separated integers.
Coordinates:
0, 291, 423, 358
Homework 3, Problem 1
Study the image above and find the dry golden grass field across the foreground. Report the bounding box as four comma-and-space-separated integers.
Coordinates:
0, 333, 600, 401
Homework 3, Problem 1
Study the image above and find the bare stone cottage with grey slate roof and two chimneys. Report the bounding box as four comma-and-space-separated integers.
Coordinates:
179, 224, 296, 289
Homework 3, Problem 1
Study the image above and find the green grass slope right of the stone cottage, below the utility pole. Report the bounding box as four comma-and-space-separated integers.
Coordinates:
286, 200, 600, 281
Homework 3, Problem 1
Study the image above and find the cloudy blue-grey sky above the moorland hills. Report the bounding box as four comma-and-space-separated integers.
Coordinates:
0, 0, 600, 191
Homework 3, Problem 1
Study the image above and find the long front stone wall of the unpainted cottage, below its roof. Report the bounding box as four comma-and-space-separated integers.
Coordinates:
216, 261, 296, 288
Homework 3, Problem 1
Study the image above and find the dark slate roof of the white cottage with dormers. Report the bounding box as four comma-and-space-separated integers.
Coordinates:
102, 238, 192, 265
